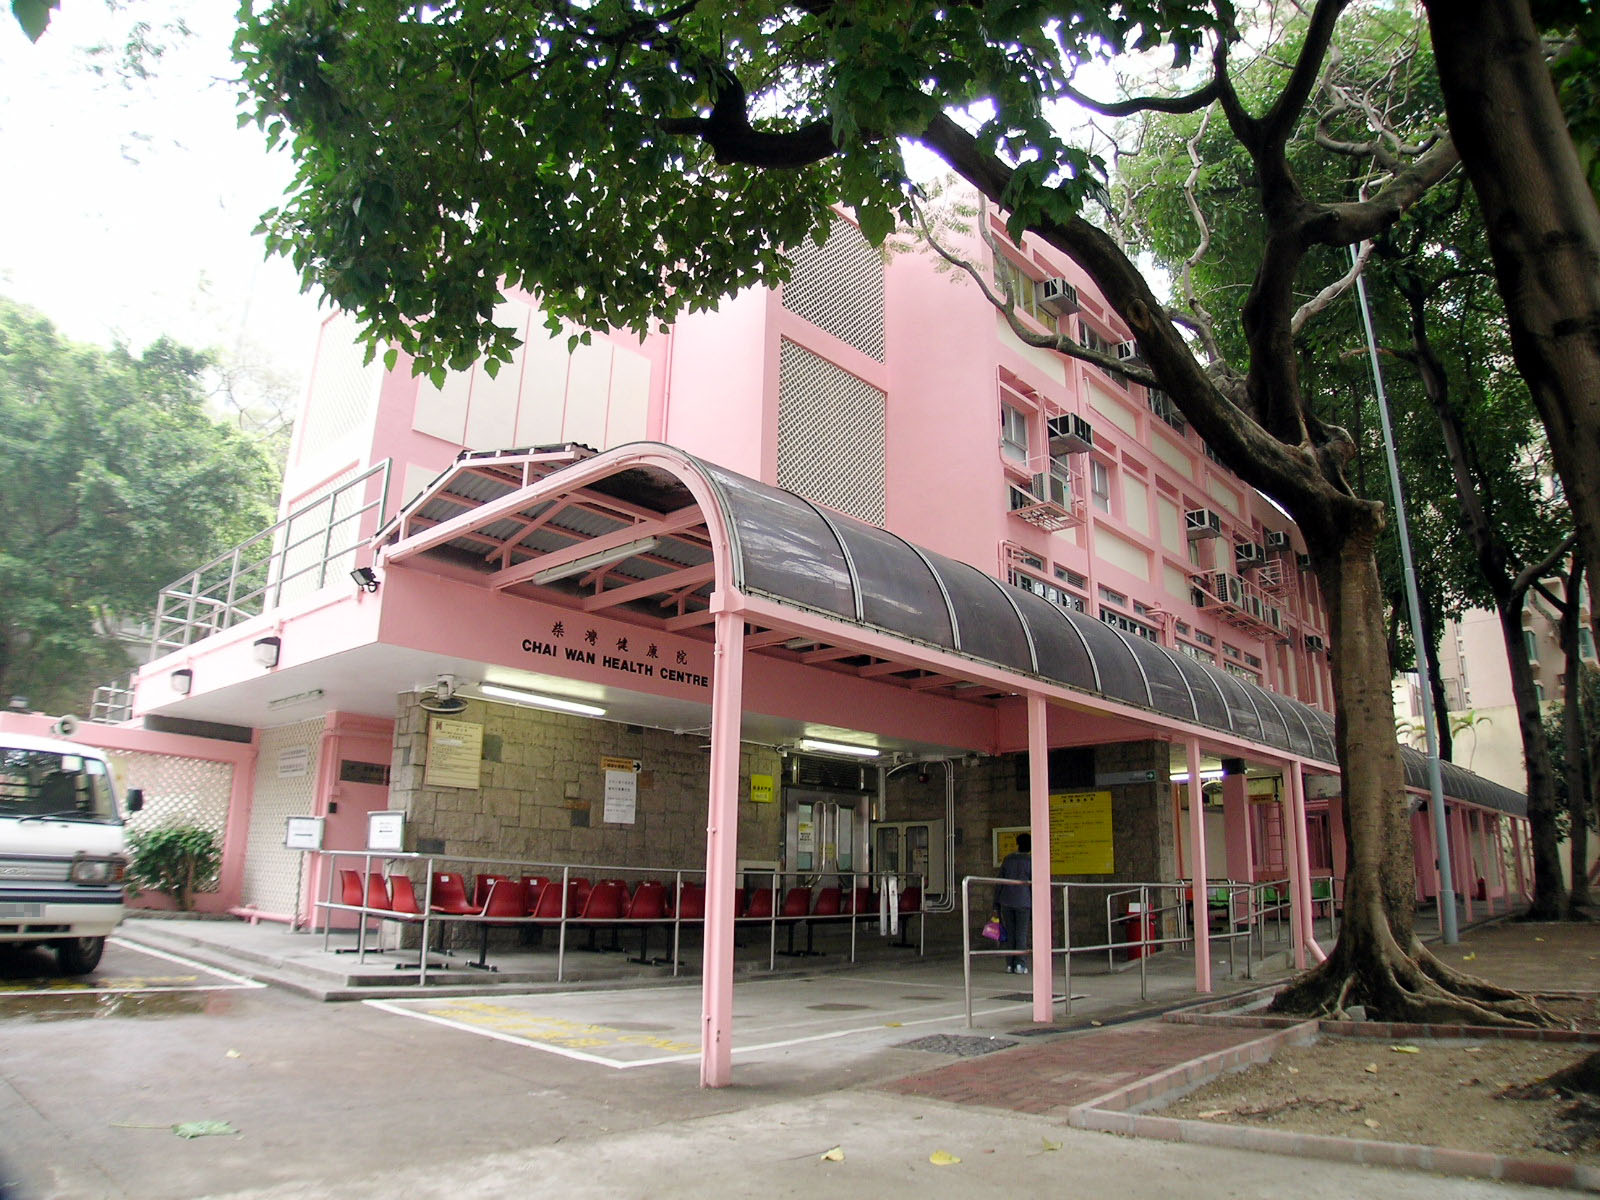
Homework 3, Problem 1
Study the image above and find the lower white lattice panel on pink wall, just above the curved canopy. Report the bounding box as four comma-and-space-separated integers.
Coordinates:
778, 341, 885, 525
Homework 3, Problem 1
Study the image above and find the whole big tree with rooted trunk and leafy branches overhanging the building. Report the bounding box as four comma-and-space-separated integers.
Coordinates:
235, 0, 1536, 1021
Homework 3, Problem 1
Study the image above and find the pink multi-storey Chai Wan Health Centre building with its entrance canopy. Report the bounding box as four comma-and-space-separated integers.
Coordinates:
28, 204, 1522, 1083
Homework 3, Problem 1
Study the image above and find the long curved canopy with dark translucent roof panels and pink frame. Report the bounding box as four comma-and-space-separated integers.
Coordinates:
376, 443, 1526, 814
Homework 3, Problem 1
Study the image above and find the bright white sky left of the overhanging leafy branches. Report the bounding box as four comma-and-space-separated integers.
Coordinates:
0, 0, 320, 379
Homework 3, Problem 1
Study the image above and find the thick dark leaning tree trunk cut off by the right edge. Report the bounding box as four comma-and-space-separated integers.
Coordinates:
1424, 0, 1600, 649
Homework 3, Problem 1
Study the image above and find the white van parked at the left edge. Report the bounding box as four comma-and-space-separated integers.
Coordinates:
0, 733, 144, 974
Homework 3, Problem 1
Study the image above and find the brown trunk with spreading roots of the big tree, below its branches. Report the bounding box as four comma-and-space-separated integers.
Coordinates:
1272, 524, 1546, 1024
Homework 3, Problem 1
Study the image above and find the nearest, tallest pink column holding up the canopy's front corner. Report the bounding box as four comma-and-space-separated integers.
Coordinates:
701, 610, 744, 1088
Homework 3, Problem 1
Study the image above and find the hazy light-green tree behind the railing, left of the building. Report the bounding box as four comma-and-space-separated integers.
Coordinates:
0, 301, 275, 712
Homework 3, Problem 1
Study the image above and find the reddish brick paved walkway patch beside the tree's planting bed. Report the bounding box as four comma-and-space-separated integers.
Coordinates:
883, 1019, 1262, 1117
